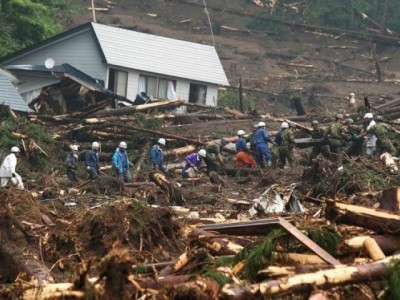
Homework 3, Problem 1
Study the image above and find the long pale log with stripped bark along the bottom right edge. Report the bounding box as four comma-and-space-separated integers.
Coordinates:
222, 255, 400, 299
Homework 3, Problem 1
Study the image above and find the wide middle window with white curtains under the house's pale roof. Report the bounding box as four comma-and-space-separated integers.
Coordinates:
139, 75, 176, 99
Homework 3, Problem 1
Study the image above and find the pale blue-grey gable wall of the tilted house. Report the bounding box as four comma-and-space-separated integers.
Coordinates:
2, 29, 107, 81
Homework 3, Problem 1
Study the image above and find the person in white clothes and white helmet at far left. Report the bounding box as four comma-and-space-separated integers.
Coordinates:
0, 146, 24, 190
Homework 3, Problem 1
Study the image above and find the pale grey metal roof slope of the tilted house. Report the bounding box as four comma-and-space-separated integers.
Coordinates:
92, 23, 229, 85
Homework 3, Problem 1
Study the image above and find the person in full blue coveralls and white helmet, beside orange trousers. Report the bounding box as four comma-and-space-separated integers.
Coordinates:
253, 122, 275, 168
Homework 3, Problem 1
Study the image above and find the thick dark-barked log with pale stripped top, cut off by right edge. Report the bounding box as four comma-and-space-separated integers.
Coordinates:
325, 200, 400, 234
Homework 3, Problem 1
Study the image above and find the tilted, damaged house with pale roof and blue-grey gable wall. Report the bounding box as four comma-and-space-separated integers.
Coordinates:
0, 23, 229, 106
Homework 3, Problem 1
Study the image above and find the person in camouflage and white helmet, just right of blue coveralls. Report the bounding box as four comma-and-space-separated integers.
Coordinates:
275, 122, 297, 169
